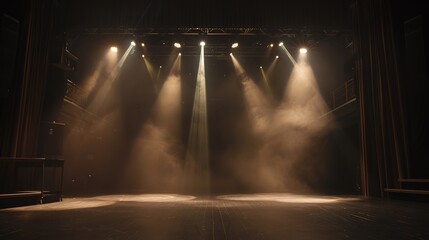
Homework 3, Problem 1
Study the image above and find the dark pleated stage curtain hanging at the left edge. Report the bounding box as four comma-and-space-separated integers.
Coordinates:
2, 0, 53, 157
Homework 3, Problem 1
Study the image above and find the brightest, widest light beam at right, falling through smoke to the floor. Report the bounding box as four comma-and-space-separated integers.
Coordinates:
261, 49, 335, 192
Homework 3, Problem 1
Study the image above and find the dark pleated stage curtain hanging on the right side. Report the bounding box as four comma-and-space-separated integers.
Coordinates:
354, 0, 408, 197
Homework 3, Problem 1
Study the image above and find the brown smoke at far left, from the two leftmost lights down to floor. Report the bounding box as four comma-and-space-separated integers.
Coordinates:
62, 47, 135, 195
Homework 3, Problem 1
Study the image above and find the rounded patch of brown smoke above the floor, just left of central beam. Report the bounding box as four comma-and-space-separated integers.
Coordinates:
124, 121, 183, 192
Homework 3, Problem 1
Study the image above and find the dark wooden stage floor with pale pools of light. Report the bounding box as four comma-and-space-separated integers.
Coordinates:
0, 194, 429, 240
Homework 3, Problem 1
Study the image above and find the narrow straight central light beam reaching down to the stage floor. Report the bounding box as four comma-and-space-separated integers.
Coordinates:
185, 44, 210, 194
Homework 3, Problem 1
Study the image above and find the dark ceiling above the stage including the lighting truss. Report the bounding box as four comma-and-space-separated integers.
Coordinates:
58, 0, 352, 58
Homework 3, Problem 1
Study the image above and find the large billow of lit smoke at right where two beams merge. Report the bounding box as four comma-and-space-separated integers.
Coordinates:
234, 56, 334, 193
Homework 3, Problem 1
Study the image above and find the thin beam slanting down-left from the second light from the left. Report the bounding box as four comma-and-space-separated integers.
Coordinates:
87, 45, 134, 114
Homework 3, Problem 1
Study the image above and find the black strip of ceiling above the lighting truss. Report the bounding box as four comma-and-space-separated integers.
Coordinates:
61, 0, 351, 35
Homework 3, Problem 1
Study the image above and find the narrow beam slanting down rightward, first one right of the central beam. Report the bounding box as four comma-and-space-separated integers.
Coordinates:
231, 55, 271, 135
